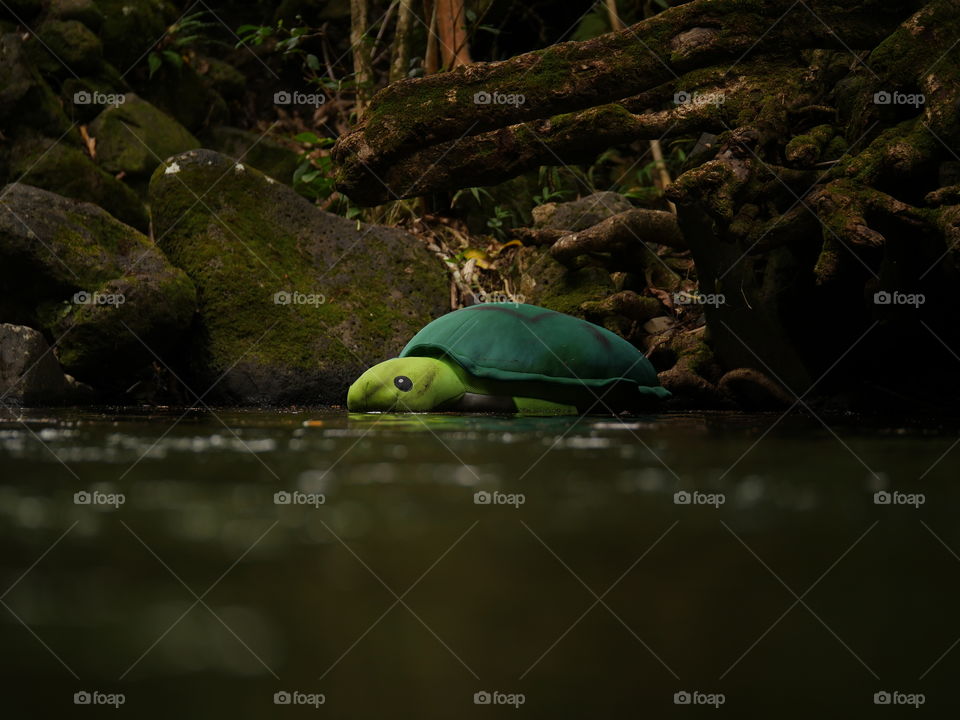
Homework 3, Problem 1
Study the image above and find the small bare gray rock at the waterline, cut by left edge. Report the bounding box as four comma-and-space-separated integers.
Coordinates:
0, 323, 93, 405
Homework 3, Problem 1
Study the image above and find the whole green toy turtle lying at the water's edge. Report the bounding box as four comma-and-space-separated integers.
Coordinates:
347, 303, 670, 414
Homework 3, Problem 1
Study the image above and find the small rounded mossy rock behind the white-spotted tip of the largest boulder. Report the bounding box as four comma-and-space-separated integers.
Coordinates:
90, 93, 200, 178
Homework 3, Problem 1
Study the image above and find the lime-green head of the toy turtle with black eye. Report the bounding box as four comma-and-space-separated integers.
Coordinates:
347, 357, 466, 412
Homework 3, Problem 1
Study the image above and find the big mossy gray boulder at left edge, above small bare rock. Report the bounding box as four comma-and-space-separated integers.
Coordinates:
0, 183, 196, 391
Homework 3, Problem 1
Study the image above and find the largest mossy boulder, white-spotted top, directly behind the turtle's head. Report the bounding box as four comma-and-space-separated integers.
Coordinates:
150, 150, 449, 404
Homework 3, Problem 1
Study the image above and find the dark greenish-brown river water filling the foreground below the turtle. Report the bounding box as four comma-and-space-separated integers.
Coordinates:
0, 411, 960, 718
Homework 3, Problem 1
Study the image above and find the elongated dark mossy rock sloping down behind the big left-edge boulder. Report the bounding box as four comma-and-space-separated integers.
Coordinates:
10, 131, 150, 232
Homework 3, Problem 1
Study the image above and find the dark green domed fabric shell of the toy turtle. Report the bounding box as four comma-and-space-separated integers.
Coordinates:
400, 303, 670, 397
